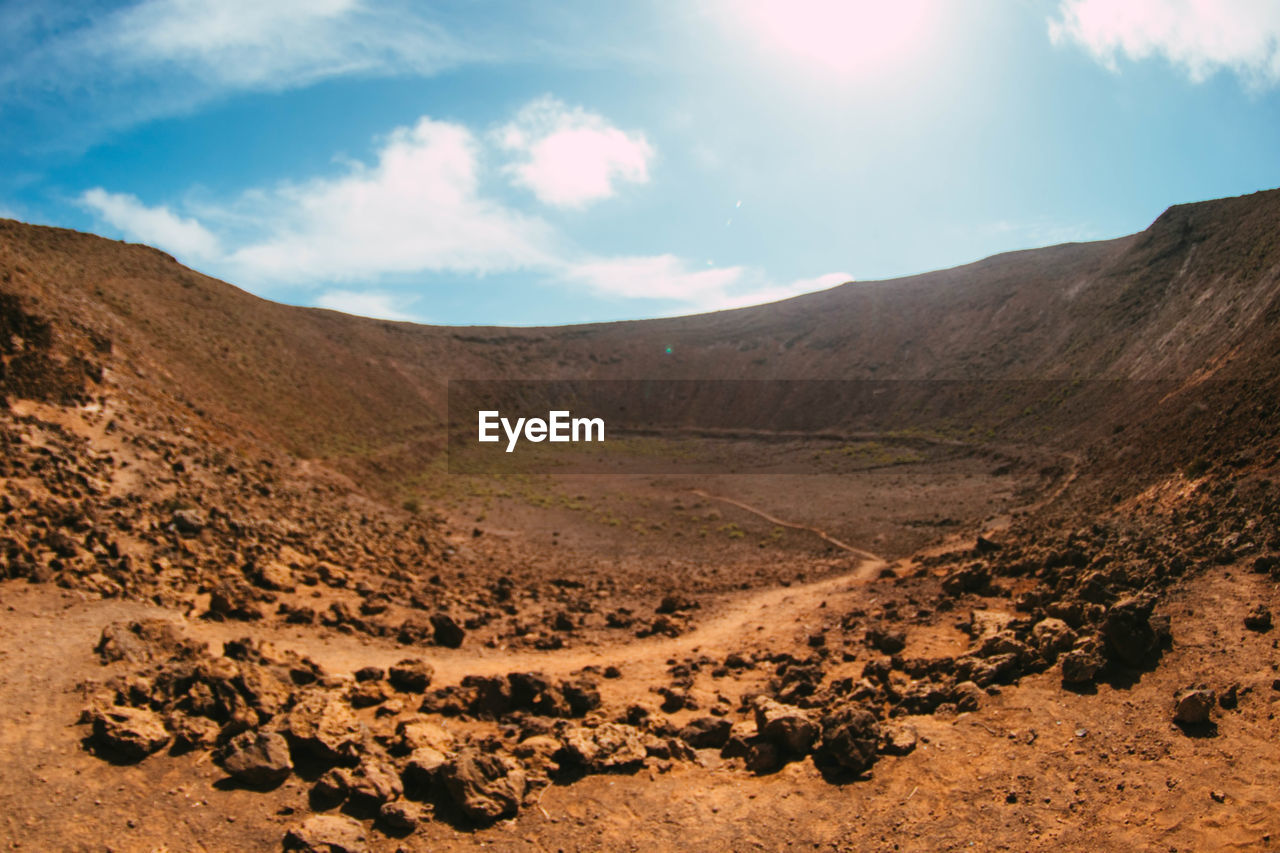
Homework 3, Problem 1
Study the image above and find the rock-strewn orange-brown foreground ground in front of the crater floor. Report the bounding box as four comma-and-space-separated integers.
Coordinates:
0, 379, 1280, 850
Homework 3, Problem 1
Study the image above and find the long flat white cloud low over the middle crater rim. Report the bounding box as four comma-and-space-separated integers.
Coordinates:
562, 255, 852, 311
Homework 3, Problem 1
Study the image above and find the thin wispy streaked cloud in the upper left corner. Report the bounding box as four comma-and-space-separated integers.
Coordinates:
0, 0, 473, 147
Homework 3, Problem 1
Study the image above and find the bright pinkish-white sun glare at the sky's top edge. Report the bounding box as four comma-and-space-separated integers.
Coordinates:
728, 0, 938, 78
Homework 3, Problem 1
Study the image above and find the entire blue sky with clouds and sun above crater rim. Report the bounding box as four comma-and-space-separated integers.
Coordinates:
0, 0, 1280, 325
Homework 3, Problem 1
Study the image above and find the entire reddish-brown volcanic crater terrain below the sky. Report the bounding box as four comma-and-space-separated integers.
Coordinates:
0, 191, 1280, 850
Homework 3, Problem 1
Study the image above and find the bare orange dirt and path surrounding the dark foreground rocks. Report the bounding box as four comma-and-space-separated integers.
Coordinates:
0, 548, 1280, 850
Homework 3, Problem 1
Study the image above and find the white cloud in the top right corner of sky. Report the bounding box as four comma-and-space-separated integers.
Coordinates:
1050, 0, 1280, 86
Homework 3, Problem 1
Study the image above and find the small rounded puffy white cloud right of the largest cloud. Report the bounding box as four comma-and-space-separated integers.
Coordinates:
497, 97, 653, 207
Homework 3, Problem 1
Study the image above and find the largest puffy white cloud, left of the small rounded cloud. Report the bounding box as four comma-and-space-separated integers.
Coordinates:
228, 118, 556, 282
